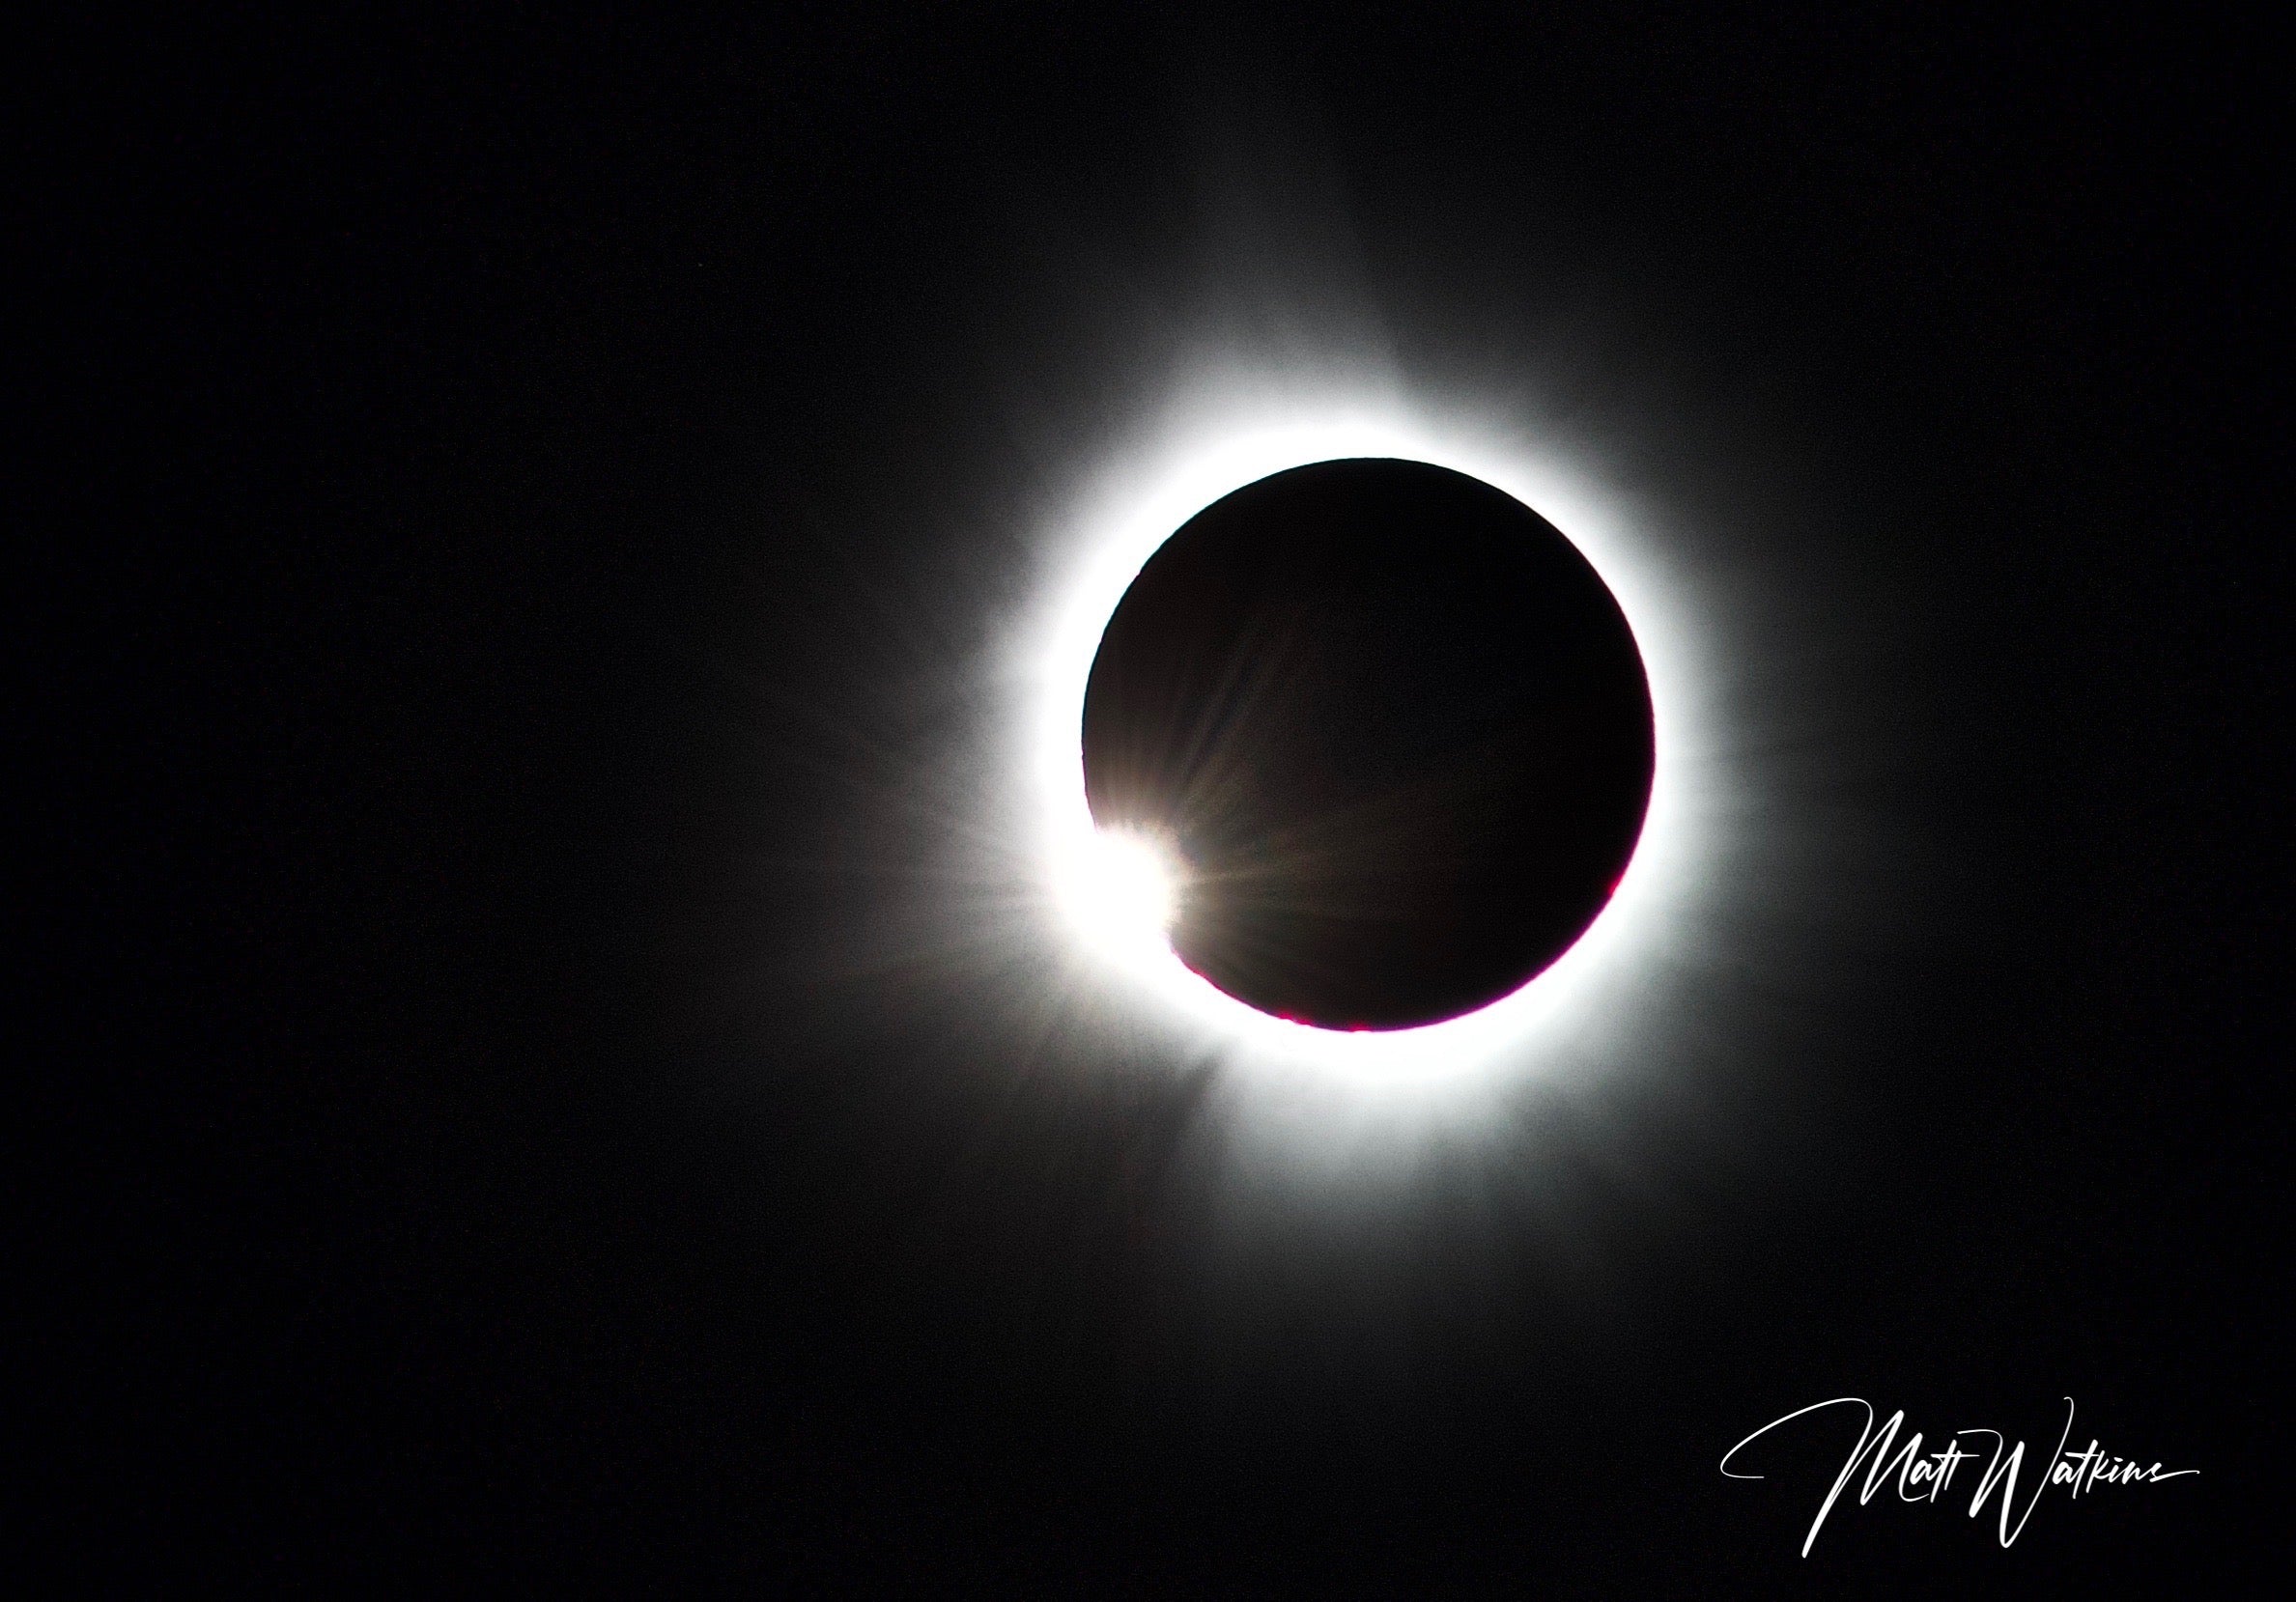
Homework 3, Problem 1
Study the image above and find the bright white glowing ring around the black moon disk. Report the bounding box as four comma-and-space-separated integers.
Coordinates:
1024, 402, 1727, 1088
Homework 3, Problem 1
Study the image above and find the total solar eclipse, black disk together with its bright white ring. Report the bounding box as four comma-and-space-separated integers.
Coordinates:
1019, 406, 1743, 1104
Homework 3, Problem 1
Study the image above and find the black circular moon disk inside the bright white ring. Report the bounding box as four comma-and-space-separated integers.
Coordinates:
1084, 459, 1653, 1028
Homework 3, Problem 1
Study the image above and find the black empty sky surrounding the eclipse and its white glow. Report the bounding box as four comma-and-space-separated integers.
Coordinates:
16, 7, 2284, 1595
